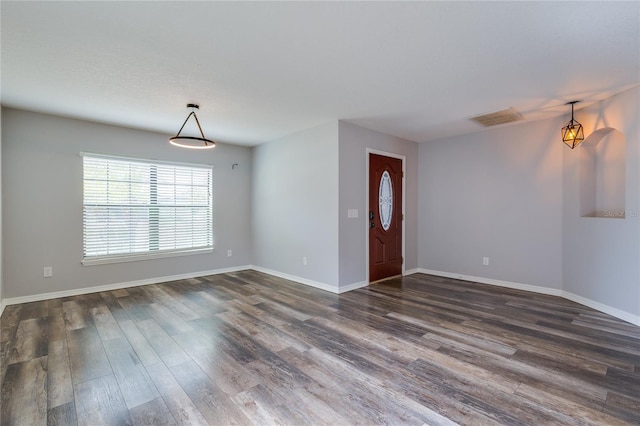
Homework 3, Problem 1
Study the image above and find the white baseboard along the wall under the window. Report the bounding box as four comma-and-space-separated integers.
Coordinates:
2, 265, 251, 311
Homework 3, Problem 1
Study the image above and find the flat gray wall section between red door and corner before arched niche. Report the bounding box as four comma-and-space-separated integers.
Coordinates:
418, 116, 564, 290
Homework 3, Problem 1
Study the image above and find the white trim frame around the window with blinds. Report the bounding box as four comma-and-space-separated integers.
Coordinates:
79, 151, 215, 266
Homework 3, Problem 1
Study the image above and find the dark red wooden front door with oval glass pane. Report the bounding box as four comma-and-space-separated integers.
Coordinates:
369, 154, 403, 282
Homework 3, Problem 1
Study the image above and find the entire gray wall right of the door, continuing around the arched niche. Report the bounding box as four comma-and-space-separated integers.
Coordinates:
418, 87, 640, 321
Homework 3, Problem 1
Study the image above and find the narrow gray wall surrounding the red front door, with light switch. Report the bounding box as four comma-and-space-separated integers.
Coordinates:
338, 121, 418, 287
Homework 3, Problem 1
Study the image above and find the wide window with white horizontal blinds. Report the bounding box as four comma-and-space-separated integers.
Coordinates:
82, 154, 213, 265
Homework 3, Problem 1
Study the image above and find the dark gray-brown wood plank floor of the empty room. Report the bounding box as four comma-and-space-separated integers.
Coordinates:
1, 271, 640, 426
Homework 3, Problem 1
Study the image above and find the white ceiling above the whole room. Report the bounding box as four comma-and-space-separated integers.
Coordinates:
0, 1, 640, 145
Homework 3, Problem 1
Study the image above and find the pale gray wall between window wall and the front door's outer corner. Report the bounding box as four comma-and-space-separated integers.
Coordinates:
252, 121, 339, 289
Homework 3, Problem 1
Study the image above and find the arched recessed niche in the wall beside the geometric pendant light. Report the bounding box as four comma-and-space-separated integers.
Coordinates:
578, 127, 626, 219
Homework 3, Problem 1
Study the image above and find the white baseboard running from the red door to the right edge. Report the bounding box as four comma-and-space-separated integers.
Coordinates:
418, 268, 640, 326
